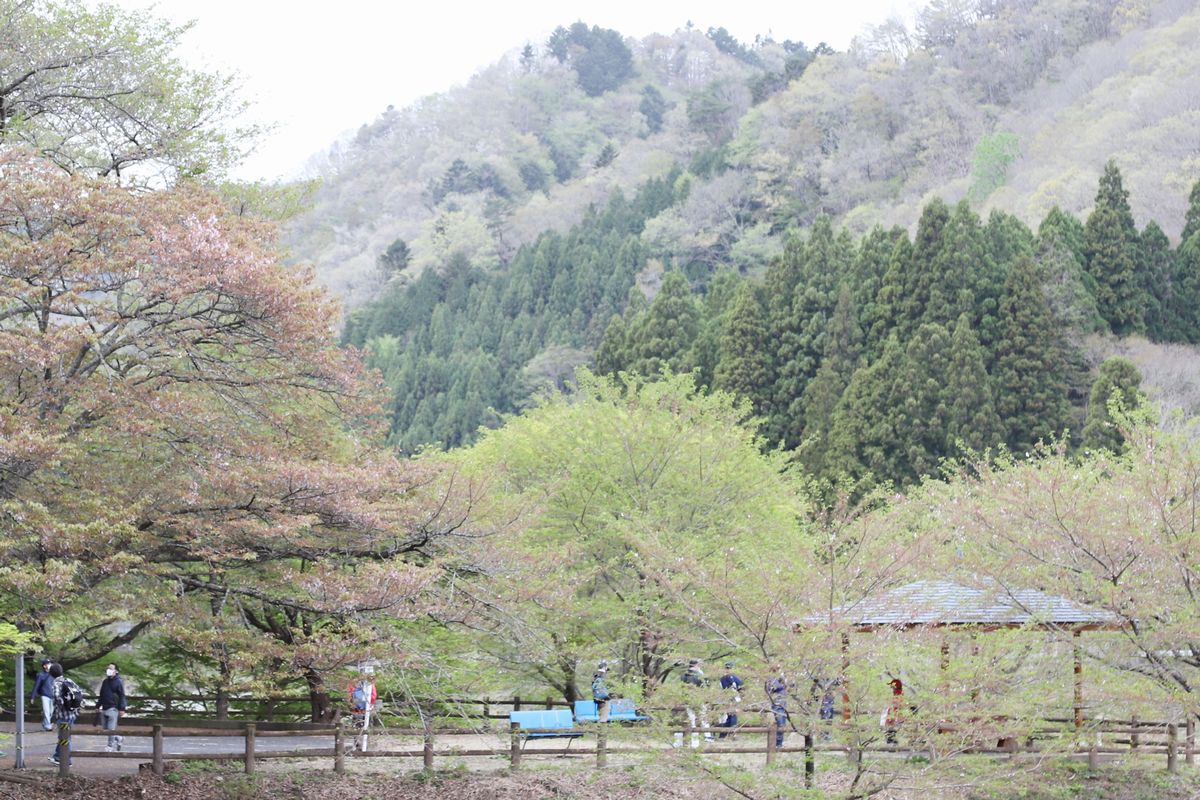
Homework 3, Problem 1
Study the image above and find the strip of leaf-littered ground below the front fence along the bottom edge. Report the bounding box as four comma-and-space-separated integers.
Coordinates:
0, 753, 1200, 800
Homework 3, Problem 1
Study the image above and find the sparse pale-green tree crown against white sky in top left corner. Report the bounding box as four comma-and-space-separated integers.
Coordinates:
0, 0, 257, 181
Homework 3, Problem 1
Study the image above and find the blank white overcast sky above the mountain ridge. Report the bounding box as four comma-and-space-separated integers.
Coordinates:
109, 0, 920, 180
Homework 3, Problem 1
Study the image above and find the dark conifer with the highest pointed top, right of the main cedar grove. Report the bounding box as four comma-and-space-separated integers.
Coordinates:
1084, 161, 1146, 336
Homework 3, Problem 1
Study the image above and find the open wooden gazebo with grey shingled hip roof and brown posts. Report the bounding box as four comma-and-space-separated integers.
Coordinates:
796, 581, 1121, 728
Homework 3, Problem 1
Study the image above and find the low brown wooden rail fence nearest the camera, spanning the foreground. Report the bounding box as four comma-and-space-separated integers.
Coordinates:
44, 698, 1198, 786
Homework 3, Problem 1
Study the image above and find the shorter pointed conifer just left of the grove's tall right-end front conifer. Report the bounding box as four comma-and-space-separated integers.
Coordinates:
944, 314, 1004, 456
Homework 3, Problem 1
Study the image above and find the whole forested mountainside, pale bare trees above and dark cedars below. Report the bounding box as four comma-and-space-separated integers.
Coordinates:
300, 0, 1200, 482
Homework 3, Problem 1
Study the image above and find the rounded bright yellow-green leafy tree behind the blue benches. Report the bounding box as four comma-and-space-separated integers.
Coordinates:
455, 372, 803, 700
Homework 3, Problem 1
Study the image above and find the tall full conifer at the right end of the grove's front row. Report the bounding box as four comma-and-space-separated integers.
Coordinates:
994, 259, 1069, 453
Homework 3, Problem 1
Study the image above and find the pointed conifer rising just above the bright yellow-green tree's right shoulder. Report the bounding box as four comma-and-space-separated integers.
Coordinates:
714, 281, 775, 415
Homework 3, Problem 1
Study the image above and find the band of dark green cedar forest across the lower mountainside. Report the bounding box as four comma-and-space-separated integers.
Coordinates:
346, 162, 1200, 485
